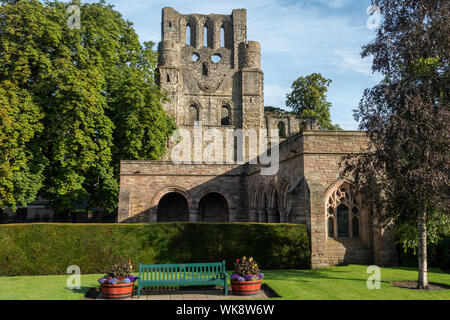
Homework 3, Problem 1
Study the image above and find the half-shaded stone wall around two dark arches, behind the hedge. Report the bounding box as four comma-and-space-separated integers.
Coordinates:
118, 161, 247, 222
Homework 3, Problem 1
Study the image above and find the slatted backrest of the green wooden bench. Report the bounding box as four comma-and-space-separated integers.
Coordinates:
139, 261, 226, 281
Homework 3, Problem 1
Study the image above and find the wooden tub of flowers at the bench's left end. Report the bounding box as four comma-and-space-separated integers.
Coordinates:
98, 260, 137, 299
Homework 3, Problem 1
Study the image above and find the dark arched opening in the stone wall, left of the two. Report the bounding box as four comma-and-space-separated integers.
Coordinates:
157, 192, 189, 222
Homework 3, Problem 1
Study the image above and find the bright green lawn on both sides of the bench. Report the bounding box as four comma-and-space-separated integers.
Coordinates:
0, 265, 450, 300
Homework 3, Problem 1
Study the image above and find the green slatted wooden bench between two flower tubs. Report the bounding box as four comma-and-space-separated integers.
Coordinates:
138, 261, 228, 298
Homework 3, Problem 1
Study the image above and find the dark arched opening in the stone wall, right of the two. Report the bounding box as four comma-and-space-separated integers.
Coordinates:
198, 192, 229, 222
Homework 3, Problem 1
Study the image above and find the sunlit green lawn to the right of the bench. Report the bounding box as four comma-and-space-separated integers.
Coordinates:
264, 265, 450, 300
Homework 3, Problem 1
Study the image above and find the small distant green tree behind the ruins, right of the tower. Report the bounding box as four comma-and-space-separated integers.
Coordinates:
286, 73, 340, 130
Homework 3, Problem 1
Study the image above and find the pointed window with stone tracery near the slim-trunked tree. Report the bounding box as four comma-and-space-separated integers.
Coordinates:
326, 183, 360, 238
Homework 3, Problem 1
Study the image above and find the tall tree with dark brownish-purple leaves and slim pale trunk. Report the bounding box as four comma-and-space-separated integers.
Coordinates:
343, 0, 450, 288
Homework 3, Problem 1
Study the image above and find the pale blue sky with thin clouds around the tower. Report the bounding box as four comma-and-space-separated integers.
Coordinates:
74, 0, 381, 130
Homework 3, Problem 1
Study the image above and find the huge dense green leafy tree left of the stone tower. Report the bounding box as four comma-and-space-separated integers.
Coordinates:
0, 0, 174, 218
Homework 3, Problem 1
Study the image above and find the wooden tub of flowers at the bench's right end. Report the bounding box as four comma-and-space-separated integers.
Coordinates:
230, 257, 264, 296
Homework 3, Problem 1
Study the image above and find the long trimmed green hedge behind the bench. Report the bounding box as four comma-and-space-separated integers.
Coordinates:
0, 223, 310, 276
